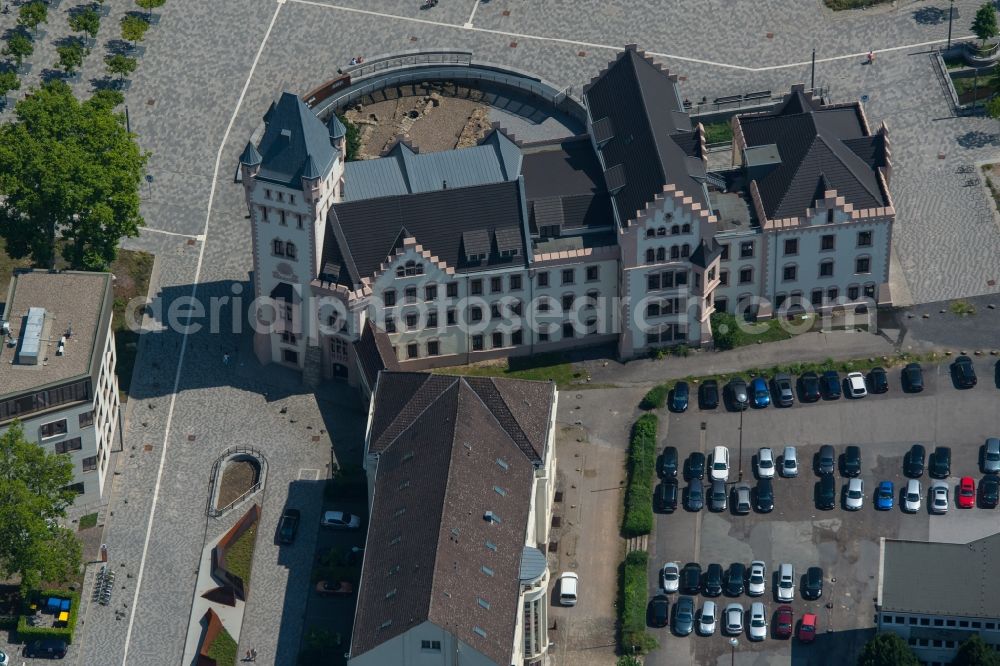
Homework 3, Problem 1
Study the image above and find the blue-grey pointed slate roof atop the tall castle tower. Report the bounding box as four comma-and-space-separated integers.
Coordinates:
257, 92, 336, 188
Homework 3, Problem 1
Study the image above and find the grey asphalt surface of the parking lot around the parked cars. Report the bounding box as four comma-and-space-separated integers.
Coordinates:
646, 357, 1000, 664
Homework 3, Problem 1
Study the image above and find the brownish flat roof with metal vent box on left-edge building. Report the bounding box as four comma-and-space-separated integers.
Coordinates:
0, 271, 111, 398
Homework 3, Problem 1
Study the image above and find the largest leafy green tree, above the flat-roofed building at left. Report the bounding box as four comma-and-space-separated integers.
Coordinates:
0, 80, 149, 270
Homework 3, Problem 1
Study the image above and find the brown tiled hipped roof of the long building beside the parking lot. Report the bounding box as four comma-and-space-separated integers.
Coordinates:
351, 372, 555, 664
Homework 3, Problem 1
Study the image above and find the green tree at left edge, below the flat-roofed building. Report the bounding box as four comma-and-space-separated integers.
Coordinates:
0, 421, 81, 592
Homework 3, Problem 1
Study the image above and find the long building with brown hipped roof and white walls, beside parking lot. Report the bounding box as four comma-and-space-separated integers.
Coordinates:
349, 371, 557, 666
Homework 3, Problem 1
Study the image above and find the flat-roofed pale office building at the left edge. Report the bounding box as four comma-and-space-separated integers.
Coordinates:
0, 271, 120, 504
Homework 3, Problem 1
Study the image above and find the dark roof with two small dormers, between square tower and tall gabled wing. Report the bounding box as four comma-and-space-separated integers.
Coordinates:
321, 182, 526, 286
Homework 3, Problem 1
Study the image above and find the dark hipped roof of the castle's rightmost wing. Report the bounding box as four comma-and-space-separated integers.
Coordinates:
739, 86, 888, 219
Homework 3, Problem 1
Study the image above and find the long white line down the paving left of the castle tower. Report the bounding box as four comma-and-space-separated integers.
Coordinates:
122, 3, 283, 666
